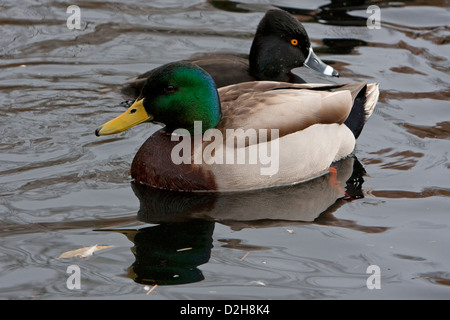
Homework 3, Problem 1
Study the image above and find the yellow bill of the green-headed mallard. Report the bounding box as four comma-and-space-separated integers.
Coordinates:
95, 99, 153, 136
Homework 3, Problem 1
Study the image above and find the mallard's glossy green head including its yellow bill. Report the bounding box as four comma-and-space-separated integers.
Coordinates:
95, 62, 222, 136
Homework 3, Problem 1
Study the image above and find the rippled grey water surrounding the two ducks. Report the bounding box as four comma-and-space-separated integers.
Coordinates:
0, 0, 450, 300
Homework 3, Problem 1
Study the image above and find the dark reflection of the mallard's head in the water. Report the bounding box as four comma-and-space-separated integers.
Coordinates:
117, 220, 214, 285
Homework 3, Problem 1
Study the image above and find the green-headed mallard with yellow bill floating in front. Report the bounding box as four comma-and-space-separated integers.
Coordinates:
95, 62, 379, 191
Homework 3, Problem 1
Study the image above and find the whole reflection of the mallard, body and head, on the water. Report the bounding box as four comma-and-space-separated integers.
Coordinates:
108, 158, 385, 285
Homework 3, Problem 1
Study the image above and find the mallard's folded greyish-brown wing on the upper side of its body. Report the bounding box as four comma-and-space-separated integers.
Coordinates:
218, 82, 353, 136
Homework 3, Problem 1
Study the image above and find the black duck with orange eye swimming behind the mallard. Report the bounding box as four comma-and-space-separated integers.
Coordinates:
121, 9, 339, 98
